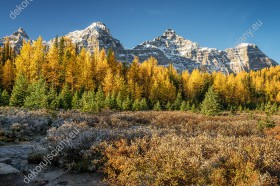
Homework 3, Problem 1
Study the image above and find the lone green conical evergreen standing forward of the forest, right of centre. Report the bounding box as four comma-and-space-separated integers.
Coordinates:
201, 87, 220, 116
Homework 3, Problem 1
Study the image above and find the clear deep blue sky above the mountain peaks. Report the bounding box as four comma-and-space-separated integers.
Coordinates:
0, 0, 280, 63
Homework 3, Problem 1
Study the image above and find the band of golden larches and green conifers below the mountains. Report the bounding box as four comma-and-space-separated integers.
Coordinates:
0, 37, 280, 112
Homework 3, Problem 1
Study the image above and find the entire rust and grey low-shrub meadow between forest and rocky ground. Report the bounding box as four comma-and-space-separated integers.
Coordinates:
0, 108, 280, 186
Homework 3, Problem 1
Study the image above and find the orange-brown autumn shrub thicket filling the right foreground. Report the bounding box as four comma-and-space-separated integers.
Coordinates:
99, 134, 280, 185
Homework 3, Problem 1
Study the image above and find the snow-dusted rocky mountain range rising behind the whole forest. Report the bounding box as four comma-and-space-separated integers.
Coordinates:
0, 22, 278, 74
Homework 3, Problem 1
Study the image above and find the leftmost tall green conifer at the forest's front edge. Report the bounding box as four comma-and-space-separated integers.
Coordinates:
10, 75, 28, 107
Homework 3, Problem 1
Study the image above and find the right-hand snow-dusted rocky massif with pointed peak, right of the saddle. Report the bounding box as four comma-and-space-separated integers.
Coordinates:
118, 29, 278, 74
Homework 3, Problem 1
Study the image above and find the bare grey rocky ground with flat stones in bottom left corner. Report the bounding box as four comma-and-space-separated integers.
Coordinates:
0, 141, 106, 186
